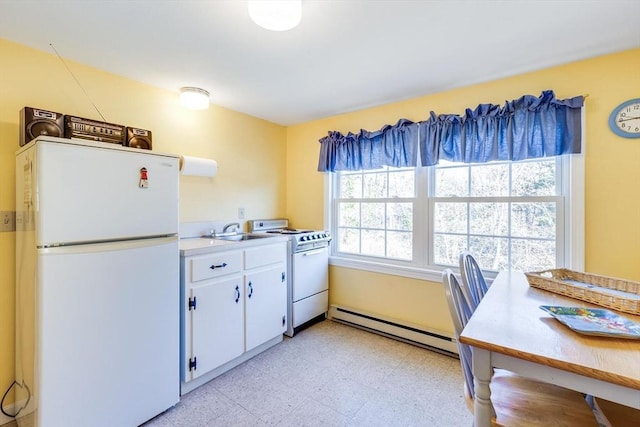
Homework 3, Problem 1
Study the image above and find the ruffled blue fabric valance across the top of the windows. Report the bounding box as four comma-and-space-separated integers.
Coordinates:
318, 90, 584, 172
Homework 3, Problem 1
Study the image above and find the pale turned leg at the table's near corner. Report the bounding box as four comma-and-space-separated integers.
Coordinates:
473, 348, 493, 427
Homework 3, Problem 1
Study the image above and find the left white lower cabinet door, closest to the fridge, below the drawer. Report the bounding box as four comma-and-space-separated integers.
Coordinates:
190, 275, 244, 379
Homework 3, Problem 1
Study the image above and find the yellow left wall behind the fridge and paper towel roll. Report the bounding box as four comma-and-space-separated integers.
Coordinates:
0, 39, 286, 402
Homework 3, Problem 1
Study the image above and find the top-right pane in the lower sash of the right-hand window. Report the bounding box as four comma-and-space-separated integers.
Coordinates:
511, 202, 556, 239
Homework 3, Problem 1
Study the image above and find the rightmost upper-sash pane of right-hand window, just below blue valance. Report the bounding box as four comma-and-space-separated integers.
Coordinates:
511, 160, 556, 196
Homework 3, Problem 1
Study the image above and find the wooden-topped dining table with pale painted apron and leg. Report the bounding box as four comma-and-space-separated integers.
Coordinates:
460, 272, 640, 427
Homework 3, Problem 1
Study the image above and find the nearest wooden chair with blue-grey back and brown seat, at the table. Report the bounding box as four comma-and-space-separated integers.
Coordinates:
442, 269, 598, 427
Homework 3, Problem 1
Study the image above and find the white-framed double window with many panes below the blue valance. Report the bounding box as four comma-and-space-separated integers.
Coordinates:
328, 156, 583, 281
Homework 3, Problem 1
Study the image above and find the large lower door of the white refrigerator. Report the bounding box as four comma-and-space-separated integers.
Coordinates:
32, 238, 180, 427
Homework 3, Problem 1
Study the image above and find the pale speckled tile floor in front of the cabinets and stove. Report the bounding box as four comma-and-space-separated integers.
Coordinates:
144, 320, 472, 427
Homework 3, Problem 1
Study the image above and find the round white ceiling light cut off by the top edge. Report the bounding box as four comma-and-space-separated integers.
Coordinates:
247, 0, 302, 31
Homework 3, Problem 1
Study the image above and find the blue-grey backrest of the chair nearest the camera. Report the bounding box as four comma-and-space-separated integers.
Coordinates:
442, 268, 473, 397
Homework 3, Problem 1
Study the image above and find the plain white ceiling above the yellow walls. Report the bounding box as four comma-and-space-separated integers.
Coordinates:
0, 0, 640, 125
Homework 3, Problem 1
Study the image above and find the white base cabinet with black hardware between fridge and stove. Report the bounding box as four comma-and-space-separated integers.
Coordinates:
181, 240, 287, 394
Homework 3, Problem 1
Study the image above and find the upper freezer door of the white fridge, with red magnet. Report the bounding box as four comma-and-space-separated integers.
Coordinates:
24, 141, 179, 246
